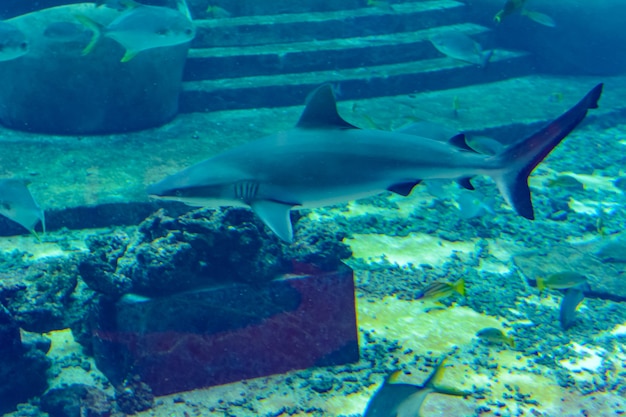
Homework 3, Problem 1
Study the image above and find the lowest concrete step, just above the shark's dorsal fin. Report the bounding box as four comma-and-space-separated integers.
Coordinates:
180, 50, 532, 113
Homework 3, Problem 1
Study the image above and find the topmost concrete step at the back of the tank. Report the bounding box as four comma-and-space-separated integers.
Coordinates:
192, 0, 464, 48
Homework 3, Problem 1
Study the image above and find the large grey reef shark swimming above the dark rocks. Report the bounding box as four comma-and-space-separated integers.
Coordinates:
147, 84, 603, 242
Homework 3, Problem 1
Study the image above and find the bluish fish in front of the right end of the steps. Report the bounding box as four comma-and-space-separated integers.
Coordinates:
428, 31, 493, 67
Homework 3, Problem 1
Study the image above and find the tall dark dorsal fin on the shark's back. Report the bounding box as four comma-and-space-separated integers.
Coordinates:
296, 84, 356, 129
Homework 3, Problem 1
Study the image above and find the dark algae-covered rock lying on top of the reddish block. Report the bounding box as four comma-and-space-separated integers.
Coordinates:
79, 208, 351, 297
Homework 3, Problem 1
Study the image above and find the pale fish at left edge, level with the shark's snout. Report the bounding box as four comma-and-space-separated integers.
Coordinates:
0, 178, 46, 236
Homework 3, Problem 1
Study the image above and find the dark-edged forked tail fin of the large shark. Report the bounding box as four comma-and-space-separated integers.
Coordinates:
493, 84, 603, 220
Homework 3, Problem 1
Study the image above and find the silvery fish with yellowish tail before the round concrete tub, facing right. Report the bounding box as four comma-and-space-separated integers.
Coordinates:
76, 5, 196, 62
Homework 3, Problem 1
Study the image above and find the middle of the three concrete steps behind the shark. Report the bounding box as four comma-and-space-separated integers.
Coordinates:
184, 23, 491, 81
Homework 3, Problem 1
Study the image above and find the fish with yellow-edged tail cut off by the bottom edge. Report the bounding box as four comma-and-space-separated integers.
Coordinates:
363, 360, 468, 417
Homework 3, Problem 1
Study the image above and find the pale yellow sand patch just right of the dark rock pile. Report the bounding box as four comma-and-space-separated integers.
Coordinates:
345, 233, 476, 266
